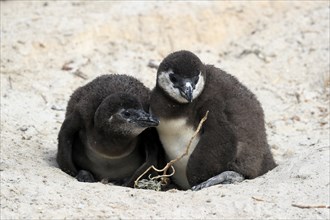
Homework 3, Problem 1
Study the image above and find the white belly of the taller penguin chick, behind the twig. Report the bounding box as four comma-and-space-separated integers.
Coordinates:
157, 118, 199, 189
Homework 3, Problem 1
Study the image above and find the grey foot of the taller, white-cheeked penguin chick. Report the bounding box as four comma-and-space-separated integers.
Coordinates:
191, 171, 244, 191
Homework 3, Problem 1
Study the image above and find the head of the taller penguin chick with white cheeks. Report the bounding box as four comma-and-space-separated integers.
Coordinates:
157, 50, 205, 103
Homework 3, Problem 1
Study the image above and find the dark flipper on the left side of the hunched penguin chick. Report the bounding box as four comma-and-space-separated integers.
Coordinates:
56, 112, 80, 176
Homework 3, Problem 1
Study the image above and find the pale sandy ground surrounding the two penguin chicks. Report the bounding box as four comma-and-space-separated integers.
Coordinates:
0, 1, 330, 219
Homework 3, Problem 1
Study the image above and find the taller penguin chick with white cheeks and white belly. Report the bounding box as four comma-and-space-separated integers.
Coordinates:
150, 51, 276, 190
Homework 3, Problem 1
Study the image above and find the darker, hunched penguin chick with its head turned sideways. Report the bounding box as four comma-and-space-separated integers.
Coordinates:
56, 75, 159, 187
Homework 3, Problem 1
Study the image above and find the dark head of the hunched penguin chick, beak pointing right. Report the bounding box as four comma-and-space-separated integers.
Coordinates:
94, 93, 159, 136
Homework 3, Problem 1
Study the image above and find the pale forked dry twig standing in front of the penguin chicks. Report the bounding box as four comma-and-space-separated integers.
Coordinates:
134, 111, 209, 188
